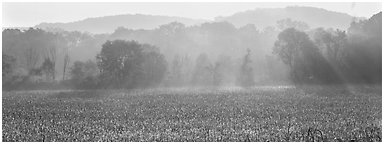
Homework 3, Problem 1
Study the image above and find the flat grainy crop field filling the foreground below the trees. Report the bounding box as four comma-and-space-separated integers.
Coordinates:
2, 86, 382, 142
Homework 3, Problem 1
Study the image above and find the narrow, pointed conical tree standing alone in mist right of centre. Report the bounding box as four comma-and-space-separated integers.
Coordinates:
237, 49, 255, 87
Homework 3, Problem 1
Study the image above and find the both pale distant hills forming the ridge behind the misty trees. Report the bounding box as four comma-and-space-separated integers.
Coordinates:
35, 6, 366, 34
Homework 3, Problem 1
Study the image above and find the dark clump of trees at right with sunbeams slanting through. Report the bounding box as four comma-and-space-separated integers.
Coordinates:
274, 13, 382, 84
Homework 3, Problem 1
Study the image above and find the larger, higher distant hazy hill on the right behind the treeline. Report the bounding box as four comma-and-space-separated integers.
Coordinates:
215, 6, 365, 30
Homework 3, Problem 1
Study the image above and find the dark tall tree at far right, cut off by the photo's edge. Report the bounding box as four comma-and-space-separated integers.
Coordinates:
343, 12, 382, 83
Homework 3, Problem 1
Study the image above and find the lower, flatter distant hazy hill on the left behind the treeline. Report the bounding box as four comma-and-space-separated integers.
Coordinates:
35, 14, 205, 34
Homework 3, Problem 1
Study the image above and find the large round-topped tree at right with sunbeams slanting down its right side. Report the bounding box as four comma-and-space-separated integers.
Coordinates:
273, 28, 339, 84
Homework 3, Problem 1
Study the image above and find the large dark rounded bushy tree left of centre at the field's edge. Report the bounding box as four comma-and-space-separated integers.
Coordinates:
96, 40, 143, 88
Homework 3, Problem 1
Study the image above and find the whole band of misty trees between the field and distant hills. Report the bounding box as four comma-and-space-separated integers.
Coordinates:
2, 12, 382, 90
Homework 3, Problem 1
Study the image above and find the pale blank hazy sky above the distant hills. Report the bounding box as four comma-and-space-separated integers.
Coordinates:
2, 2, 382, 27
